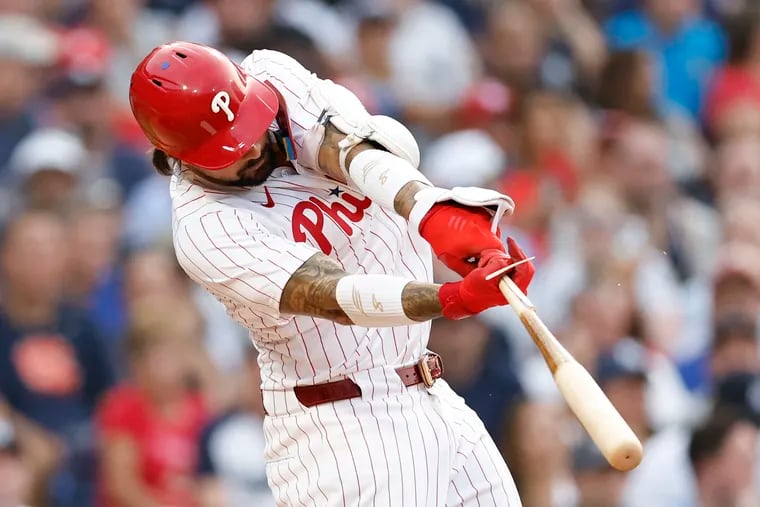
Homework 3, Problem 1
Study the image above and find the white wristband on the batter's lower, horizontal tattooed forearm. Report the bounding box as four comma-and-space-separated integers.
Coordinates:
335, 275, 419, 327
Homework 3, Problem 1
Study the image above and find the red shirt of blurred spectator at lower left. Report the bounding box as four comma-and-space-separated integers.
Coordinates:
97, 385, 206, 507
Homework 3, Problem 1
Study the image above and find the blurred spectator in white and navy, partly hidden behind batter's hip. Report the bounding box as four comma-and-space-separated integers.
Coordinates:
198, 346, 274, 507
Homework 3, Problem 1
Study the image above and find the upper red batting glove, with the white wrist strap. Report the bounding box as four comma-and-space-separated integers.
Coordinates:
419, 202, 504, 276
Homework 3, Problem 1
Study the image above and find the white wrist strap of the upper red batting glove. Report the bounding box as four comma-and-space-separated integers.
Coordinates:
409, 187, 515, 232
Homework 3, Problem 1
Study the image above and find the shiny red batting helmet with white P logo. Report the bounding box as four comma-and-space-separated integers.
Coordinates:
129, 42, 278, 170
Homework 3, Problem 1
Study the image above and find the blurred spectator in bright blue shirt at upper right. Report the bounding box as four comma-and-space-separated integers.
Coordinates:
604, 0, 726, 121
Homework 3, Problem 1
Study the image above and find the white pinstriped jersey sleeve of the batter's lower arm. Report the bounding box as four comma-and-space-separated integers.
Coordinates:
174, 208, 318, 330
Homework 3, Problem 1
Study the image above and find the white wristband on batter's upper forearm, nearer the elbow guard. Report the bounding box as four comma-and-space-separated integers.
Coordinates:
348, 150, 431, 210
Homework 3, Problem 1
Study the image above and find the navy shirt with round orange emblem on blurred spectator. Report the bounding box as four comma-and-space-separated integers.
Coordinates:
0, 308, 114, 507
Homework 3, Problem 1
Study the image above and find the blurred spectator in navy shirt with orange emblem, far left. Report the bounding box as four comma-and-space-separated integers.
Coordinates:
0, 212, 113, 507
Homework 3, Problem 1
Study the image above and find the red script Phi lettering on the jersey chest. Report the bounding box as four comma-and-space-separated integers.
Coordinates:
292, 187, 372, 255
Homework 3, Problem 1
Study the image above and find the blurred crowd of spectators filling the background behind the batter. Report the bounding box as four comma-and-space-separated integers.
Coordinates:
0, 0, 760, 507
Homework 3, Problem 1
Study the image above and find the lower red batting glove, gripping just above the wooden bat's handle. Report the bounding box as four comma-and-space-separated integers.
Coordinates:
438, 244, 535, 320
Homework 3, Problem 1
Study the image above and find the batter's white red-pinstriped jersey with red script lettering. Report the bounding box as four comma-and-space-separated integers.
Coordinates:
171, 50, 432, 390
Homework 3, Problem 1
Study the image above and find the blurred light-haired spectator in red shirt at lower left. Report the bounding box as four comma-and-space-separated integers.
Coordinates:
97, 297, 214, 507
